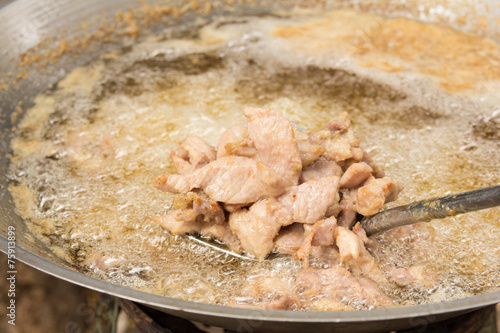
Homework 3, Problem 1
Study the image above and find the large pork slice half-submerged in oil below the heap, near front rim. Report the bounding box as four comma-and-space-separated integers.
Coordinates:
297, 266, 392, 308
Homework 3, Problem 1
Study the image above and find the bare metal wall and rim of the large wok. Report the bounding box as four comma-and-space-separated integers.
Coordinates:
0, 0, 500, 332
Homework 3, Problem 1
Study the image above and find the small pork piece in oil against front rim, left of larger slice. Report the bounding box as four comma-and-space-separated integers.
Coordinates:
230, 276, 301, 310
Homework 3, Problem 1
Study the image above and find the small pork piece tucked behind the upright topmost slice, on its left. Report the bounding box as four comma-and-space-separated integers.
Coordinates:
217, 124, 257, 158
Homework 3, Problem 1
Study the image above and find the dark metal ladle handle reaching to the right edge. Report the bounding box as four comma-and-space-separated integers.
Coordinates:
361, 185, 500, 236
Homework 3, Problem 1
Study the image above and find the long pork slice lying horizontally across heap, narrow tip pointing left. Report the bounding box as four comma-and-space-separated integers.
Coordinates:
155, 156, 284, 204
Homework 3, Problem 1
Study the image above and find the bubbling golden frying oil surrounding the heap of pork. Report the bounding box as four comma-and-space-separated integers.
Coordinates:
10, 11, 500, 308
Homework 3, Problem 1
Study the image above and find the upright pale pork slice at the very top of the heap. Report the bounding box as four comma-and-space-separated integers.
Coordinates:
243, 108, 302, 189
